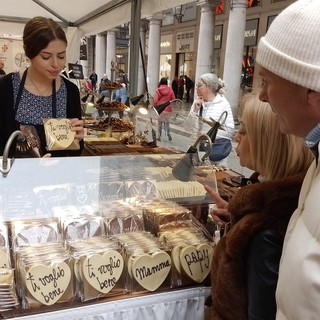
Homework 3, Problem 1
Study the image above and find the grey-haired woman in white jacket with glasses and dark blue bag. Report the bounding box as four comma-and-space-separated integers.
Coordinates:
189, 73, 234, 163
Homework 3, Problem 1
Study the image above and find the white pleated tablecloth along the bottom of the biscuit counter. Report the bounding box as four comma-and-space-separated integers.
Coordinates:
16, 287, 210, 320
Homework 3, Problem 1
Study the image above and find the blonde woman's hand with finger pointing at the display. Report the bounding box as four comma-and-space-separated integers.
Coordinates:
204, 185, 230, 226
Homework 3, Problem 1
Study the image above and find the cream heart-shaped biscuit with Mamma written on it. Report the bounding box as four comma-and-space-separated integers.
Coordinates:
131, 251, 171, 291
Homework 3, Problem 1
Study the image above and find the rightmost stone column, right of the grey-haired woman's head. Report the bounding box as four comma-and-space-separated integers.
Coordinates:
223, 0, 247, 119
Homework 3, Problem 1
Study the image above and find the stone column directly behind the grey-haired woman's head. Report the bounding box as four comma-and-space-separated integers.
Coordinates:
195, 0, 214, 81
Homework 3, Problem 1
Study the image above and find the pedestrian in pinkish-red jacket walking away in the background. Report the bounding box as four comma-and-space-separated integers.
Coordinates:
153, 78, 175, 141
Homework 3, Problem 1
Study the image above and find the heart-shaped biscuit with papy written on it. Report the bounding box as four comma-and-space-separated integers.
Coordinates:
180, 243, 213, 283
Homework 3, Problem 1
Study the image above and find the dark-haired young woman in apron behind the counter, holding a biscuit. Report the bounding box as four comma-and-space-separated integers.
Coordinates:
0, 17, 84, 157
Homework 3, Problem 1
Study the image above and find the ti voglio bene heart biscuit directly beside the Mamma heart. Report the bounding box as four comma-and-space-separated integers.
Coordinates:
82, 250, 124, 293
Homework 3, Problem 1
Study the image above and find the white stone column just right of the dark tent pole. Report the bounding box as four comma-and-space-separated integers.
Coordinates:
147, 13, 163, 96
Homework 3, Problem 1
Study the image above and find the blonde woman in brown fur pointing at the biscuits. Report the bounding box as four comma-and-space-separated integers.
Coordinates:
206, 94, 312, 320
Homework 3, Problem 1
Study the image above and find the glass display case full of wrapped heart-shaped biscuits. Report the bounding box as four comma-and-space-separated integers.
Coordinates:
0, 154, 240, 319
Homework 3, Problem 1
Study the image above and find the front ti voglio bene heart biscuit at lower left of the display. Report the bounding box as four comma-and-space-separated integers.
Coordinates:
25, 262, 71, 306
